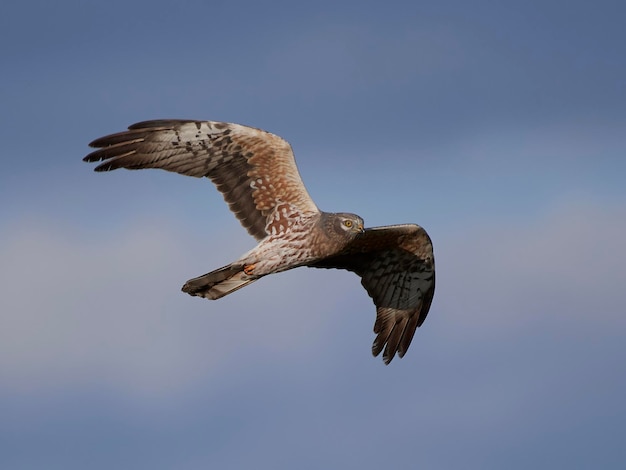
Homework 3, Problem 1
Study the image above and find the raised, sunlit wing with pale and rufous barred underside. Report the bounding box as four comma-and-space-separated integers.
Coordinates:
83, 120, 318, 240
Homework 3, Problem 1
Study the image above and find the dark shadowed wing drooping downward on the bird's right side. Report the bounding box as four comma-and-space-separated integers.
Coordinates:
312, 224, 435, 364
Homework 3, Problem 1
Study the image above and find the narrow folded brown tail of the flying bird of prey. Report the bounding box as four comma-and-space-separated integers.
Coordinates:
182, 263, 258, 300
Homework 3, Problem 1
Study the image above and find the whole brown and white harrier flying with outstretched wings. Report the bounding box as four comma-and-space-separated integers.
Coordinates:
84, 120, 435, 364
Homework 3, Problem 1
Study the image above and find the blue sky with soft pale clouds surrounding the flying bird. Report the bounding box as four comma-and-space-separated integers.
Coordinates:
0, 0, 626, 469
